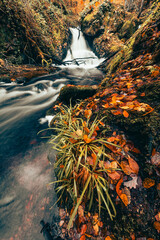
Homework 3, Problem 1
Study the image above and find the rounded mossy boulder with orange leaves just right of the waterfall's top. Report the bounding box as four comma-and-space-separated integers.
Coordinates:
81, 1, 125, 57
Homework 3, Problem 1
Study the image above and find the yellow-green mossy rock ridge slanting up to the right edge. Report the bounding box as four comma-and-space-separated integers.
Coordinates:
104, 4, 160, 74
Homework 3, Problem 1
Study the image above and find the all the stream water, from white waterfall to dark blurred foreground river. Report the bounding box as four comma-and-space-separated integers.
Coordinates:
0, 28, 103, 240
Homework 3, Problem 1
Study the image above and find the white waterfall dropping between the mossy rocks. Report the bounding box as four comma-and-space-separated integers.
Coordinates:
63, 28, 104, 68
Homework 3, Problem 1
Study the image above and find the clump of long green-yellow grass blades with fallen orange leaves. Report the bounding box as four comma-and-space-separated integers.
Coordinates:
50, 106, 120, 229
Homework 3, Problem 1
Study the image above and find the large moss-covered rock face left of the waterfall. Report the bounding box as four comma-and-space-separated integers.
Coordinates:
0, 0, 69, 64
